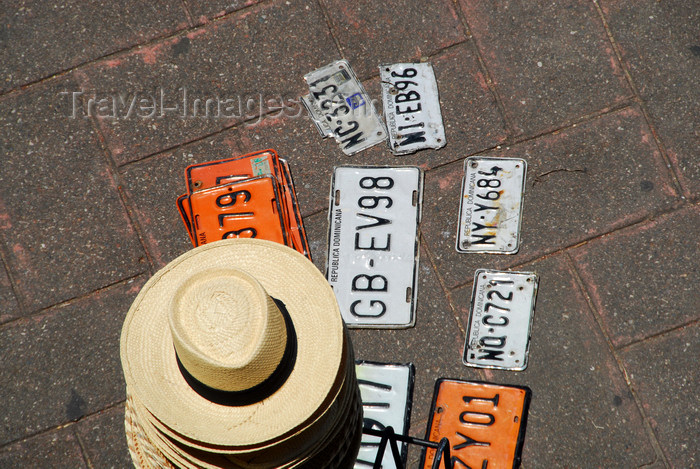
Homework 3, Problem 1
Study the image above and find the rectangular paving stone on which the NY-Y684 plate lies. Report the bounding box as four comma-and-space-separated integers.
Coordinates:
422, 107, 675, 287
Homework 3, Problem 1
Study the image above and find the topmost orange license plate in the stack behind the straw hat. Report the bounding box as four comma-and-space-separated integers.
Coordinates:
190, 176, 287, 246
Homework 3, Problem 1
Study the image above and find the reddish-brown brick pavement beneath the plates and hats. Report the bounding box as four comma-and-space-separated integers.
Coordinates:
0, 0, 700, 469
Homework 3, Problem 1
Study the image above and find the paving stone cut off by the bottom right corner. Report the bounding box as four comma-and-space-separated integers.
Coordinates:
620, 322, 700, 468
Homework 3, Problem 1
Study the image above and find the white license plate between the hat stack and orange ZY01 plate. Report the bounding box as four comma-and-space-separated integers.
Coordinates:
355, 361, 415, 469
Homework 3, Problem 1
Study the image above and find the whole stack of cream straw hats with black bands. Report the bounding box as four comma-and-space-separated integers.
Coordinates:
121, 239, 362, 469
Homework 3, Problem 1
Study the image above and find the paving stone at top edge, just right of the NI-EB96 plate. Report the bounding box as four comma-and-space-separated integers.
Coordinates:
460, 0, 631, 135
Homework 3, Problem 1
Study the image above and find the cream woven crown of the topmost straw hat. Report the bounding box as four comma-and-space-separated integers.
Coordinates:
169, 269, 287, 391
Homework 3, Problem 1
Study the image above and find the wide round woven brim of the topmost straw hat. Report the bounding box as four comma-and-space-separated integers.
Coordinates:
121, 239, 343, 447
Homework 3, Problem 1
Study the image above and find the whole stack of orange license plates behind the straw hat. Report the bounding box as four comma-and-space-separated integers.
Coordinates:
177, 150, 311, 259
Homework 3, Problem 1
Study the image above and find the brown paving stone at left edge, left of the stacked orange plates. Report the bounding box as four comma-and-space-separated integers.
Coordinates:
0, 80, 147, 311
